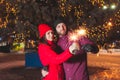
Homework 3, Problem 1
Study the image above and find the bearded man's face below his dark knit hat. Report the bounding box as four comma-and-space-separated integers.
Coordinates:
56, 23, 67, 36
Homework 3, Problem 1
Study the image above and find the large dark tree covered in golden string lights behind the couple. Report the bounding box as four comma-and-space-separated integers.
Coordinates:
0, 0, 120, 44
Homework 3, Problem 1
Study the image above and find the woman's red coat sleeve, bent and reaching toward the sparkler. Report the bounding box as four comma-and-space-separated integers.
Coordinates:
38, 46, 72, 65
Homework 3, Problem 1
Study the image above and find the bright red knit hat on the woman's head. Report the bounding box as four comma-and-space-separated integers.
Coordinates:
38, 24, 52, 38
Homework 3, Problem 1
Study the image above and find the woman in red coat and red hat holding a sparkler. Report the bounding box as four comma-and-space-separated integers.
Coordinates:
38, 24, 79, 80
